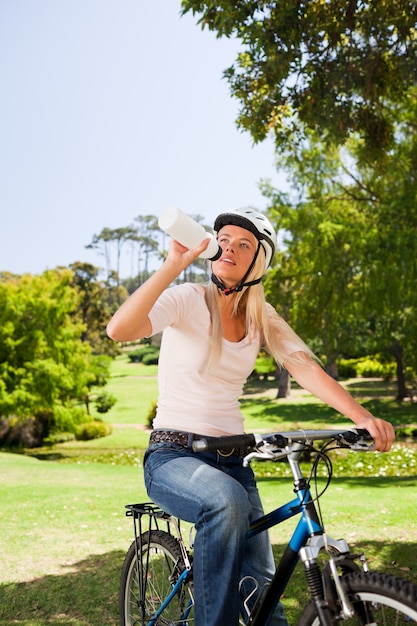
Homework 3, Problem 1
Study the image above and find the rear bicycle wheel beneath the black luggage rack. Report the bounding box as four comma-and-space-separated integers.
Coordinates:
119, 530, 194, 626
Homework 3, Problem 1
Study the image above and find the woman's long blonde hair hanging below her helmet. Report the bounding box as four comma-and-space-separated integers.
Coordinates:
205, 247, 316, 370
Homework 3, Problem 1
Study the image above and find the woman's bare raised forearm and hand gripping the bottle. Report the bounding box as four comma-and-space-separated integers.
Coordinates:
107, 239, 210, 341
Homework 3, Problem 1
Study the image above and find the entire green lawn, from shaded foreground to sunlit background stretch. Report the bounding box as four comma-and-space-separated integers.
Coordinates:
0, 357, 417, 626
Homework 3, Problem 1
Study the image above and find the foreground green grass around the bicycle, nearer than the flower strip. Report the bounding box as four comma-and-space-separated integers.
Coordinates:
0, 454, 417, 626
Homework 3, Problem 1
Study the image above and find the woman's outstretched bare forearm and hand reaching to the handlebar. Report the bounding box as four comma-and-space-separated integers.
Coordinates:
285, 355, 395, 452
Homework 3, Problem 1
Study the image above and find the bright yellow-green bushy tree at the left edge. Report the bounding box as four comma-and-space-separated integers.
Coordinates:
0, 269, 101, 438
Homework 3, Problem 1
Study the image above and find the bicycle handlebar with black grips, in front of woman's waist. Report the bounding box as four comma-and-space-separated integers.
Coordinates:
192, 428, 373, 452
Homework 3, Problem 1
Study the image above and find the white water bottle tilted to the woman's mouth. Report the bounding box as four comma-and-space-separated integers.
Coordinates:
158, 206, 222, 261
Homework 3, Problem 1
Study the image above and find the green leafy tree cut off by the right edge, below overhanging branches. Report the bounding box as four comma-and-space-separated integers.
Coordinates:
351, 89, 417, 399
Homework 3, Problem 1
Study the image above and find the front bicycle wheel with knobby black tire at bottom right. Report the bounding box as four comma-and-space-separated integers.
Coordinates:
297, 571, 417, 626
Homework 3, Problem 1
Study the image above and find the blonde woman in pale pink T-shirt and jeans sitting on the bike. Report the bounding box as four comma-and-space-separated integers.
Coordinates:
108, 209, 394, 626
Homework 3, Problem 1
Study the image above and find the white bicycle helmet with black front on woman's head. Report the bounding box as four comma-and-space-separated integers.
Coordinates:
214, 209, 277, 272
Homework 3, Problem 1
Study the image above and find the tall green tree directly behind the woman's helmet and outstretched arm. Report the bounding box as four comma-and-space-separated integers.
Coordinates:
266, 144, 367, 378
